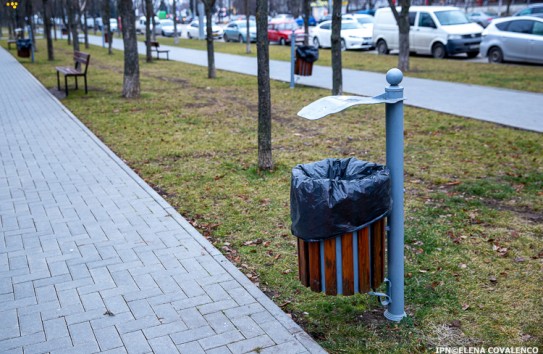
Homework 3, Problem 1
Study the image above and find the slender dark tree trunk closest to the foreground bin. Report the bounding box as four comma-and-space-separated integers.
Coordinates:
256, 0, 273, 170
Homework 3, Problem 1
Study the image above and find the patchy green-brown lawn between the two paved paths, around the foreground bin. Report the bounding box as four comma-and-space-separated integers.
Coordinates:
2, 41, 543, 353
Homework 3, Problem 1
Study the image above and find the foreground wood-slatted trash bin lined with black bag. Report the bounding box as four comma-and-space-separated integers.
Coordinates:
290, 158, 392, 295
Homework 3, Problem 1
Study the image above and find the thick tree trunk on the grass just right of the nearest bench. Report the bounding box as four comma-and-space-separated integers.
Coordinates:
118, 0, 140, 98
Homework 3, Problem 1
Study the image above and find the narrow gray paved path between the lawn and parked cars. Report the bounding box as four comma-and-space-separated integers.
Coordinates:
89, 36, 543, 132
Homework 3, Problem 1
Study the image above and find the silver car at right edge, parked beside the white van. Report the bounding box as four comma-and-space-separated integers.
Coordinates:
481, 16, 543, 64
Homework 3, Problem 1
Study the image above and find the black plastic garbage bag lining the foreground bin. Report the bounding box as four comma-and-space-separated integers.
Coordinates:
290, 158, 392, 242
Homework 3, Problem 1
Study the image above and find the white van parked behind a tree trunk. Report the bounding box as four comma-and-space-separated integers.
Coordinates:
373, 6, 483, 59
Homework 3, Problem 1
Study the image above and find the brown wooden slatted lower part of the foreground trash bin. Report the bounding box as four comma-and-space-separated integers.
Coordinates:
298, 218, 386, 295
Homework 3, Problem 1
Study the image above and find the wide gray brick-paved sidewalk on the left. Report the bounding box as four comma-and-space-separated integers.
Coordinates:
0, 48, 323, 354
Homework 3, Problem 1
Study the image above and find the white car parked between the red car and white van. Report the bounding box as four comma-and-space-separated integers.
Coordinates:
313, 20, 373, 50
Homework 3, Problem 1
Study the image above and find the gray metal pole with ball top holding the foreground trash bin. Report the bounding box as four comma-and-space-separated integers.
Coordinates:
385, 69, 406, 322
